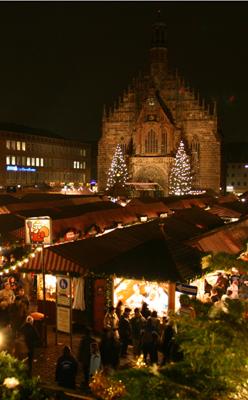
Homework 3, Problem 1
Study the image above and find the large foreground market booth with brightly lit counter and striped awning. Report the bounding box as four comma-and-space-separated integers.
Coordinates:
21, 221, 200, 331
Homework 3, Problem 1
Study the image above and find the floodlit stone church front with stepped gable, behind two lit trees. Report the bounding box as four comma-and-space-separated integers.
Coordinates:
98, 18, 221, 195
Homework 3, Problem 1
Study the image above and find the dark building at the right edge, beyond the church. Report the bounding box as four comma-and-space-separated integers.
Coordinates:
225, 142, 248, 194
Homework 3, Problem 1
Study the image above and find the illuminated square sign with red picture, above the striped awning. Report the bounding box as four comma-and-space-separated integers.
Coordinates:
25, 217, 52, 245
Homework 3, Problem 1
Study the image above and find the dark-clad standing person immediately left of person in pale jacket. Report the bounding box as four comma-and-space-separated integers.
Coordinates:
78, 326, 96, 386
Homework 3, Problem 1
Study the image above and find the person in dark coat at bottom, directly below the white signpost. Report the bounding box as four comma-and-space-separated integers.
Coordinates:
55, 346, 78, 389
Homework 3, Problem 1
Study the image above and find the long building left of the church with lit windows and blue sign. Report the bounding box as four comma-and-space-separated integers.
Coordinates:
0, 124, 91, 187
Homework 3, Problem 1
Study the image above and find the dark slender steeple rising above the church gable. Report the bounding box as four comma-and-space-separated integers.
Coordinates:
150, 11, 168, 88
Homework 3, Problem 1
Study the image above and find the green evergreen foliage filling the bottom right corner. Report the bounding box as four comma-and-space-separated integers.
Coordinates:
111, 299, 248, 400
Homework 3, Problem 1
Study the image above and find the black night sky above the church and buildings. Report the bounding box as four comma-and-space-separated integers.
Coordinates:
0, 1, 248, 141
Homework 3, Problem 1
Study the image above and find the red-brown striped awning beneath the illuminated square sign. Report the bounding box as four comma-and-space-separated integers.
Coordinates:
23, 246, 85, 275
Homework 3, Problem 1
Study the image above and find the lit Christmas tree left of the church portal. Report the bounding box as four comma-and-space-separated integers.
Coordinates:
106, 144, 128, 191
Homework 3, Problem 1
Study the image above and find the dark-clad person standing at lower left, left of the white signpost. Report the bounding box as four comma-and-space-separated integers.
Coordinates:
20, 315, 40, 376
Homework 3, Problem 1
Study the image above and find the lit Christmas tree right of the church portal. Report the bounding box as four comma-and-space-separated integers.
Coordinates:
169, 140, 192, 196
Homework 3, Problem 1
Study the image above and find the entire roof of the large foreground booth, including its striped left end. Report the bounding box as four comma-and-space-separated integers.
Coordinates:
25, 222, 200, 281
